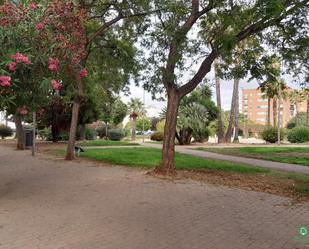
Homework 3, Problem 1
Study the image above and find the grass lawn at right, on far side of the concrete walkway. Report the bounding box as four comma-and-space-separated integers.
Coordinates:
197, 147, 309, 166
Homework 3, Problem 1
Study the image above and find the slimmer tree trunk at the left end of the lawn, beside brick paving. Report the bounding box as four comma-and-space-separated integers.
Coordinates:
65, 100, 80, 160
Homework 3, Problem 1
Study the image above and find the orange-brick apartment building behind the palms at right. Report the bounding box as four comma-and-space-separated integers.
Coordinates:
242, 88, 307, 126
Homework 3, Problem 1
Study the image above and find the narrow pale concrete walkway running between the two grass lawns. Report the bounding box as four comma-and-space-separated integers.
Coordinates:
142, 143, 309, 174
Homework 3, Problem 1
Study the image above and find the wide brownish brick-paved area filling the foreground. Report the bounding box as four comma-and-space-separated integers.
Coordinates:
0, 146, 309, 249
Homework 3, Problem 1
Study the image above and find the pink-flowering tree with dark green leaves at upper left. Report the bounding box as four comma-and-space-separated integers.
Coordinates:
0, 0, 88, 152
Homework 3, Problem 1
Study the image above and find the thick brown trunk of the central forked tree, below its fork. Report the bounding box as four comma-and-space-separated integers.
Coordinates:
155, 88, 180, 175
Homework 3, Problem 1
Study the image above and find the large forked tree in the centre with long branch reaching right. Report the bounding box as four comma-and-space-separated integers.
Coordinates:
144, 0, 308, 174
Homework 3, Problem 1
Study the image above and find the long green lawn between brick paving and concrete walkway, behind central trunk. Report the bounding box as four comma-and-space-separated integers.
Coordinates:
53, 147, 309, 196
